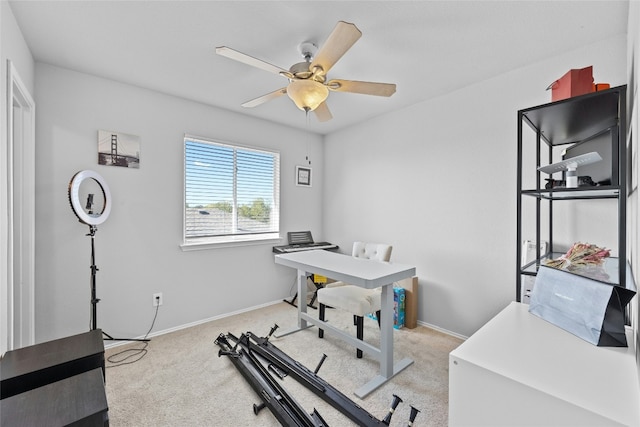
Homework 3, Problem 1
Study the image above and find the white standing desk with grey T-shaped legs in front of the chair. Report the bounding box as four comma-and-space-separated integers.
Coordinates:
275, 250, 416, 398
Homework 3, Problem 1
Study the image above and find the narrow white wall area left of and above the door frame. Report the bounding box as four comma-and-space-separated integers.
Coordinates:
0, 0, 34, 354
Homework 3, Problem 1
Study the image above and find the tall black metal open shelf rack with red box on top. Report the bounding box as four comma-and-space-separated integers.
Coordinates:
516, 86, 633, 301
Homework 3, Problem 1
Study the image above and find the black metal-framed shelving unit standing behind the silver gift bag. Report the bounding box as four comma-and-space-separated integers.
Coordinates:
516, 86, 627, 302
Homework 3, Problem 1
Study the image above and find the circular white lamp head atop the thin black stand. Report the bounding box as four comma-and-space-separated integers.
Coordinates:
69, 170, 111, 226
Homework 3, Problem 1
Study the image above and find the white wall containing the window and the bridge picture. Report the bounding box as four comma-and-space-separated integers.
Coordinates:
36, 63, 323, 342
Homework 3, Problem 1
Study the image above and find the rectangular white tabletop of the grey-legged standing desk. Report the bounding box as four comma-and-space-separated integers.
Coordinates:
275, 250, 416, 289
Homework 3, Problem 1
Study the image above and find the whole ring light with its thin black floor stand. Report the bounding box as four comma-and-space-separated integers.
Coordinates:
69, 170, 149, 341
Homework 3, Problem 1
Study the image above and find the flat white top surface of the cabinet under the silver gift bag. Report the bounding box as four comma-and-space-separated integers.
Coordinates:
450, 302, 640, 425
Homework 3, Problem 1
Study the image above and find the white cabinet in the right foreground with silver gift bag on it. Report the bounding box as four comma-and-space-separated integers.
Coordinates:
449, 302, 640, 426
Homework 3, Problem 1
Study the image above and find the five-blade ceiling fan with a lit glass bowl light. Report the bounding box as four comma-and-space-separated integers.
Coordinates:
216, 21, 396, 122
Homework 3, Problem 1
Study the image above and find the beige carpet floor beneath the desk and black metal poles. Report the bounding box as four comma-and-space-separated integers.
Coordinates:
106, 303, 462, 427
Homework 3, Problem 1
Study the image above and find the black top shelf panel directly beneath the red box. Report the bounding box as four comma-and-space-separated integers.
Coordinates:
521, 86, 625, 146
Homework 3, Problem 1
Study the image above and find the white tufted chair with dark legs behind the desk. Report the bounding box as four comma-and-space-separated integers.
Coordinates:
318, 242, 392, 358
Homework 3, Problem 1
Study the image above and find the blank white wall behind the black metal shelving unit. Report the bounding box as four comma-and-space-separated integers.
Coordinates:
323, 36, 627, 336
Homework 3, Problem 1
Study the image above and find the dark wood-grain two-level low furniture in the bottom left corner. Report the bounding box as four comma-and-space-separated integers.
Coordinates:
0, 329, 109, 427
